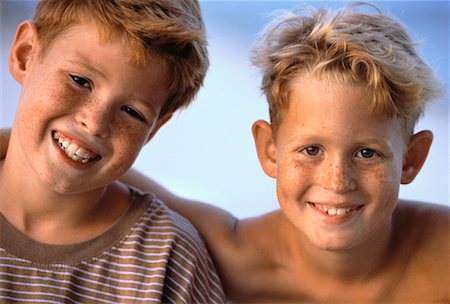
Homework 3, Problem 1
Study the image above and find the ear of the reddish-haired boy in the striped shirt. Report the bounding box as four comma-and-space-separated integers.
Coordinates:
8, 21, 39, 84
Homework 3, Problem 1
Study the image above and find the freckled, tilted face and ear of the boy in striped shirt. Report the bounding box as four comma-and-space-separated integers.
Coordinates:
10, 24, 168, 192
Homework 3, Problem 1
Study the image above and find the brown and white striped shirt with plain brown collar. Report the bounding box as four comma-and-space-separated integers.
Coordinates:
0, 190, 225, 303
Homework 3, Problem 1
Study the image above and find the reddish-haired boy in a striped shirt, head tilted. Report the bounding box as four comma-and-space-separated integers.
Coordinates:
0, 0, 224, 303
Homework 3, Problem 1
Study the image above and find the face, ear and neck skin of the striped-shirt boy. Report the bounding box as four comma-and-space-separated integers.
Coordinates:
0, 22, 170, 243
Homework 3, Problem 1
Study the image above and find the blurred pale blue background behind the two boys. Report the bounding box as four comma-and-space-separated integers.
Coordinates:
0, 0, 450, 217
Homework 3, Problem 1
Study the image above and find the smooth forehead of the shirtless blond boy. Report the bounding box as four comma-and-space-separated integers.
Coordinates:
279, 75, 402, 142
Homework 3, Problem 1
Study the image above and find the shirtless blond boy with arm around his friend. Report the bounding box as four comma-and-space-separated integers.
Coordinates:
120, 2, 450, 303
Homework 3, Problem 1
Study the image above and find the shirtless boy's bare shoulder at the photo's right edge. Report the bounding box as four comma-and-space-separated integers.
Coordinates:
394, 201, 450, 302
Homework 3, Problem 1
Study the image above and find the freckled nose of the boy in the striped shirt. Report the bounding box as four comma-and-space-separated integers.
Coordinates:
76, 100, 112, 138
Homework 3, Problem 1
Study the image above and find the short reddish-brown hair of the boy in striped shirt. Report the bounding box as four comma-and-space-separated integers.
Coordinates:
33, 0, 209, 117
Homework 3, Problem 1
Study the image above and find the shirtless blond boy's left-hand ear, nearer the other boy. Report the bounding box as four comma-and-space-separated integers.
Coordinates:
252, 120, 277, 178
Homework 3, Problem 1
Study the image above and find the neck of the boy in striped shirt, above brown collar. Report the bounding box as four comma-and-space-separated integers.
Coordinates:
0, 153, 107, 243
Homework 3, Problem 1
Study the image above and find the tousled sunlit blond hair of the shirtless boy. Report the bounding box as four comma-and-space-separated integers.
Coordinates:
252, 3, 441, 134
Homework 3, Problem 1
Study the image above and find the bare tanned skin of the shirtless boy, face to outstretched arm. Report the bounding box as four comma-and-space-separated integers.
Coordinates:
115, 74, 450, 303
